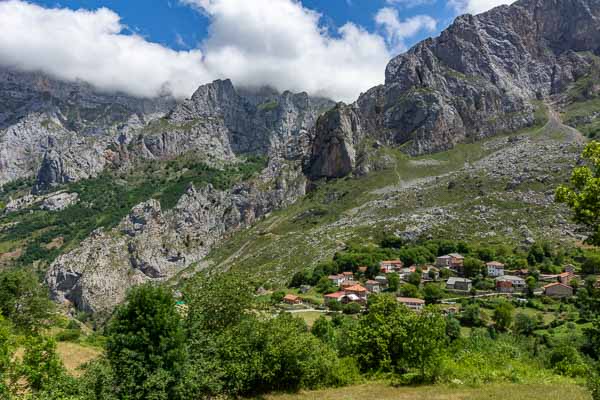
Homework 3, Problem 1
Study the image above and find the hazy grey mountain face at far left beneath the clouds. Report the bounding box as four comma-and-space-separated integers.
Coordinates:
0, 67, 175, 188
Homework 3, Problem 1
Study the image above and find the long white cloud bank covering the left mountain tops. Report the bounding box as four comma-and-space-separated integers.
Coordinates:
0, 0, 210, 97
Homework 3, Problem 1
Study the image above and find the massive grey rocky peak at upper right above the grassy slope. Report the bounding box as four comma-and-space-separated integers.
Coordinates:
313, 0, 600, 177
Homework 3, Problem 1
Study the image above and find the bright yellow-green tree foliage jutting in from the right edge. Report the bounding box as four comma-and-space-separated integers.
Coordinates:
556, 141, 600, 245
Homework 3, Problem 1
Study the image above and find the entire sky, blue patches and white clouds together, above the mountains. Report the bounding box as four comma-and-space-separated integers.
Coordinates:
0, 0, 513, 102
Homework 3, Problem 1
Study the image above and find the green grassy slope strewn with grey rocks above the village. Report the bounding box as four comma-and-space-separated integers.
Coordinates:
208, 104, 582, 282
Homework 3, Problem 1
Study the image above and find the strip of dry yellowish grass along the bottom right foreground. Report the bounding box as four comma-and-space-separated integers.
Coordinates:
262, 383, 591, 400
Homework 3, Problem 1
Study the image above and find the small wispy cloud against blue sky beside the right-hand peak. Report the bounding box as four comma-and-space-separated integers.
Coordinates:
375, 7, 437, 52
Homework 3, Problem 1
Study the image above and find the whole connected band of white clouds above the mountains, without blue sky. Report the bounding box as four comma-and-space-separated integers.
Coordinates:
0, 0, 435, 101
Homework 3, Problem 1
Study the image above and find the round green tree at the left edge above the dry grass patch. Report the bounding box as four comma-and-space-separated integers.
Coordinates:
0, 269, 53, 332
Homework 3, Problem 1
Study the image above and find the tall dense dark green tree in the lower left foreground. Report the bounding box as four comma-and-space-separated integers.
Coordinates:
106, 285, 186, 400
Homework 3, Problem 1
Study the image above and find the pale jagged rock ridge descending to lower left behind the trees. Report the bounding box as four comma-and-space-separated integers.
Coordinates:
46, 160, 306, 317
